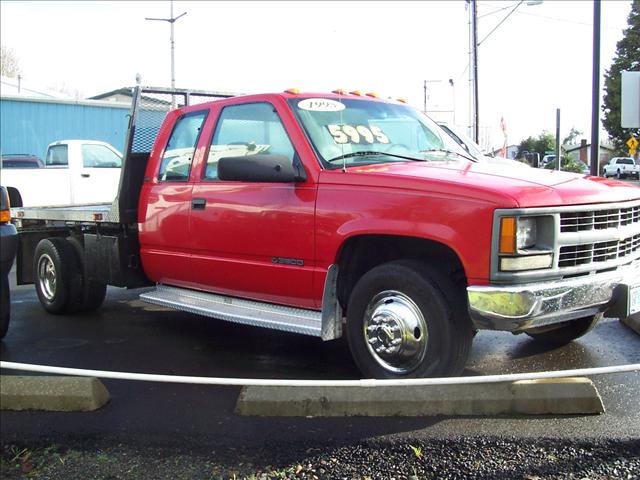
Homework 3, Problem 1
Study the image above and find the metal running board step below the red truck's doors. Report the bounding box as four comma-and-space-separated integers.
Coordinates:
140, 285, 326, 339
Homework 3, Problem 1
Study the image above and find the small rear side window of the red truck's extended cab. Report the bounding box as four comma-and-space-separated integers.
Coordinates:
158, 112, 207, 182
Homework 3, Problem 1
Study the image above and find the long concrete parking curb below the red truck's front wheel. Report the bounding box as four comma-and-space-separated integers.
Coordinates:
235, 378, 604, 417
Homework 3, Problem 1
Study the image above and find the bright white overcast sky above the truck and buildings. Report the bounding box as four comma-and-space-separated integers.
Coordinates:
0, 0, 631, 148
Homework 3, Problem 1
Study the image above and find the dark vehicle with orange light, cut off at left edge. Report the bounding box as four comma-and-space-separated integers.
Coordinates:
0, 187, 18, 338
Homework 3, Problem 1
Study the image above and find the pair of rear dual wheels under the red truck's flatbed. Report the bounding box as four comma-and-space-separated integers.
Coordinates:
34, 237, 106, 314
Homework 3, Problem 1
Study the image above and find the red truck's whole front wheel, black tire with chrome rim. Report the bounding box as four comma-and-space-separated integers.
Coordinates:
346, 260, 474, 378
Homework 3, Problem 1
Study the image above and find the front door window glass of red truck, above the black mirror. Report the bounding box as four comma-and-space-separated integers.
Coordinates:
204, 103, 295, 180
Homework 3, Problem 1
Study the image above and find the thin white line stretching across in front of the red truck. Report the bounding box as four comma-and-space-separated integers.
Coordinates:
0, 361, 640, 387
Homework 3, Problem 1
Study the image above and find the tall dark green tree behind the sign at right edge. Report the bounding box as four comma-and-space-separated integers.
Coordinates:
602, 0, 640, 153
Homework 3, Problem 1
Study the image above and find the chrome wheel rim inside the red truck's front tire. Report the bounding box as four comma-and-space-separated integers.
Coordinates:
363, 290, 429, 374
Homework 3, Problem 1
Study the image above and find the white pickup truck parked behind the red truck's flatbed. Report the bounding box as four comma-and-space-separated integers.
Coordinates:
0, 140, 122, 207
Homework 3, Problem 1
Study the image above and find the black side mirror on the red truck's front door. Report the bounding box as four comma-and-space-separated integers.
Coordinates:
218, 153, 306, 183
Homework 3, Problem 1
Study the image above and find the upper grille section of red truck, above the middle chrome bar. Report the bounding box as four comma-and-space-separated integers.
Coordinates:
560, 205, 640, 232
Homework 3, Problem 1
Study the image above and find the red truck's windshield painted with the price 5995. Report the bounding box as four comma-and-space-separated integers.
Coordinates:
289, 97, 469, 168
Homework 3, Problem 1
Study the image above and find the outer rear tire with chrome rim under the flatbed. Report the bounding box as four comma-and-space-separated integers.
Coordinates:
33, 237, 83, 314
